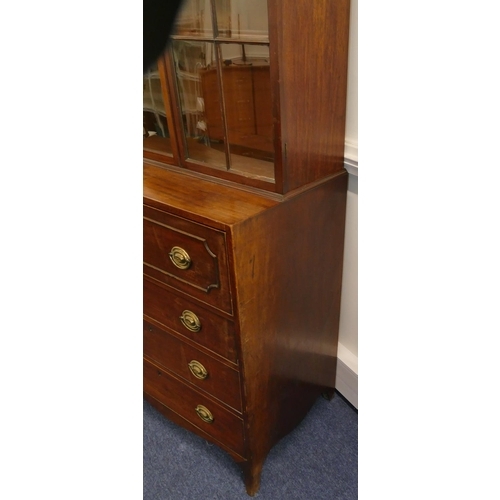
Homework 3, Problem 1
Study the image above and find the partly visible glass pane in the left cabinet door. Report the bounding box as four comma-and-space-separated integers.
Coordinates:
142, 66, 172, 155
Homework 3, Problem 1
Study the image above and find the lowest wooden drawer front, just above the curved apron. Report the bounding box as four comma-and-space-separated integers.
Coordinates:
144, 360, 244, 456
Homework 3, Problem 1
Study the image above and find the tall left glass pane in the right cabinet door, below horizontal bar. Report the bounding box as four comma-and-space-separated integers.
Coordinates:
172, 40, 227, 169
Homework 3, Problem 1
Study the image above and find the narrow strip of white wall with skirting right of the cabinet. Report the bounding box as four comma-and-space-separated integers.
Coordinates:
336, 0, 358, 408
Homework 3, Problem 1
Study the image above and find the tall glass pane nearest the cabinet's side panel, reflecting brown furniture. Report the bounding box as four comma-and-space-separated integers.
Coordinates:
221, 43, 274, 180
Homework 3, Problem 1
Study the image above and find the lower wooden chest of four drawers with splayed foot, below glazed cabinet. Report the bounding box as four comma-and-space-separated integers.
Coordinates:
143, 164, 347, 495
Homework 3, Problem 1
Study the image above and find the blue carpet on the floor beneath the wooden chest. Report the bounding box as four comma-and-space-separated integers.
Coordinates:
144, 393, 358, 500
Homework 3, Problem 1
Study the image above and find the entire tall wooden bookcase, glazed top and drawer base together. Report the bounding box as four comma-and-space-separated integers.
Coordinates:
143, 0, 350, 495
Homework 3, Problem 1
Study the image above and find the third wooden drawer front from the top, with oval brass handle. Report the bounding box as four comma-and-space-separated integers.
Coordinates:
143, 321, 241, 412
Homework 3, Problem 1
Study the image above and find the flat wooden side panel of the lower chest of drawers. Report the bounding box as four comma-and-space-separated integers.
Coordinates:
233, 174, 347, 460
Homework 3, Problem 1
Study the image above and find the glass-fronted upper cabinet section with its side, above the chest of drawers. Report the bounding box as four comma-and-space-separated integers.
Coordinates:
144, 0, 349, 194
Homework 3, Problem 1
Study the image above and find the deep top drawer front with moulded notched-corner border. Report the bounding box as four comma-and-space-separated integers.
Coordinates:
143, 206, 232, 313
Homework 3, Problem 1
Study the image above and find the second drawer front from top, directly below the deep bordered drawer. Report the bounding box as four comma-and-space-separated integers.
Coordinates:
143, 279, 237, 363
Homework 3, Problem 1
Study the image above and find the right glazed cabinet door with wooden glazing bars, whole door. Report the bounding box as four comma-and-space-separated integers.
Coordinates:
167, 0, 279, 191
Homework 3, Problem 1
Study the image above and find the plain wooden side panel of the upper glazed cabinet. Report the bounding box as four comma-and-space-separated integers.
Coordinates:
280, 0, 349, 191
